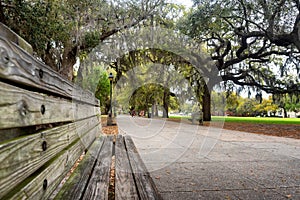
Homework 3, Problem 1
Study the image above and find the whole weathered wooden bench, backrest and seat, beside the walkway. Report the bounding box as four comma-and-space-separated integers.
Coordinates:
0, 24, 160, 200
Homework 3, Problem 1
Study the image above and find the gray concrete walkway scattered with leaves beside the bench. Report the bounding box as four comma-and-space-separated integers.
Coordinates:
117, 115, 300, 200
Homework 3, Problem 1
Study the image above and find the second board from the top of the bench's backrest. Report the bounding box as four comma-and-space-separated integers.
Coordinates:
0, 82, 100, 130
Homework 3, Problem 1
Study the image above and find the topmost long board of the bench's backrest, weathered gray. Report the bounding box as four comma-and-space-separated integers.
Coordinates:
0, 36, 99, 106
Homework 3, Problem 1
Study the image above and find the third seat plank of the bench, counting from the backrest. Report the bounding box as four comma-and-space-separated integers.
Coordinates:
115, 135, 139, 200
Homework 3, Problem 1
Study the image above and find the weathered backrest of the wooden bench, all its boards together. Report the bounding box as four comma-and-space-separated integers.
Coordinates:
0, 23, 106, 199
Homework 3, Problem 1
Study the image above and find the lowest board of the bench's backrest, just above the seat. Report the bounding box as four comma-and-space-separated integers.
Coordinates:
10, 140, 85, 199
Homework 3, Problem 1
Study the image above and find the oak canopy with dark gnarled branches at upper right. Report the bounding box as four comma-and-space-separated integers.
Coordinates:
178, 0, 300, 93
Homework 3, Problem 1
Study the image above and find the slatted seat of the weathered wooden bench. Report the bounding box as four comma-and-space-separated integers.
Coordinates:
55, 135, 161, 200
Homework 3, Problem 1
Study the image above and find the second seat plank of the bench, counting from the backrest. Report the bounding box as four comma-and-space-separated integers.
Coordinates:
83, 136, 113, 200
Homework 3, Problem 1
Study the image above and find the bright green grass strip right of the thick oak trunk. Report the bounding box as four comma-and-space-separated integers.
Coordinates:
212, 116, 300, 125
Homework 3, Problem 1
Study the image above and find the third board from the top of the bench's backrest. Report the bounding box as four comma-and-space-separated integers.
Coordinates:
0, 117, 99, 198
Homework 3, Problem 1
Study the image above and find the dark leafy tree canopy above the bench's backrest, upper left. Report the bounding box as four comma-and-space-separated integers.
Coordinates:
0, 0, 163, 79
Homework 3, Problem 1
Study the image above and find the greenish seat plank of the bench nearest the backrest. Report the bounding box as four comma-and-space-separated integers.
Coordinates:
55, 136, 106, 200
